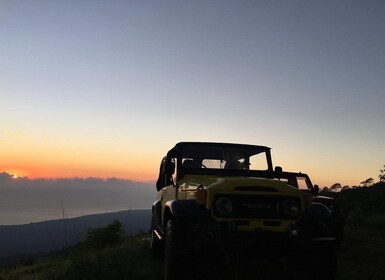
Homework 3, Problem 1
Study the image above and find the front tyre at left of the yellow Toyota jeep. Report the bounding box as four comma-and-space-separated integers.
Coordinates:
164, 217, 189, 280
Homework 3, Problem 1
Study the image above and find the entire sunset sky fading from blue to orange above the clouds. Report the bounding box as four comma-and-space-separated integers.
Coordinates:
0, 0, 385, 186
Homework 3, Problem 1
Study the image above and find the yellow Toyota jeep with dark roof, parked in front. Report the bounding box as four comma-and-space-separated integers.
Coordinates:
150, 142, 337, 280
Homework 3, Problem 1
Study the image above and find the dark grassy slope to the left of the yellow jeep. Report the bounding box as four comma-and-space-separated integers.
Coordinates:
0, 234, 163, 280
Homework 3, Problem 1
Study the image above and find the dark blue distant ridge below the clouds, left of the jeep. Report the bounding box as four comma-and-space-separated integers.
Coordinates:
0, 209, 151, 264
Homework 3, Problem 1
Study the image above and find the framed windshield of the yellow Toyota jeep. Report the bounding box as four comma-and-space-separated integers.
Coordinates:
170, 143, 273, 177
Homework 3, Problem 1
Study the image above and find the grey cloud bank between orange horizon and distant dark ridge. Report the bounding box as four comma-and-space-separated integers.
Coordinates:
0, 172, 156, 224
